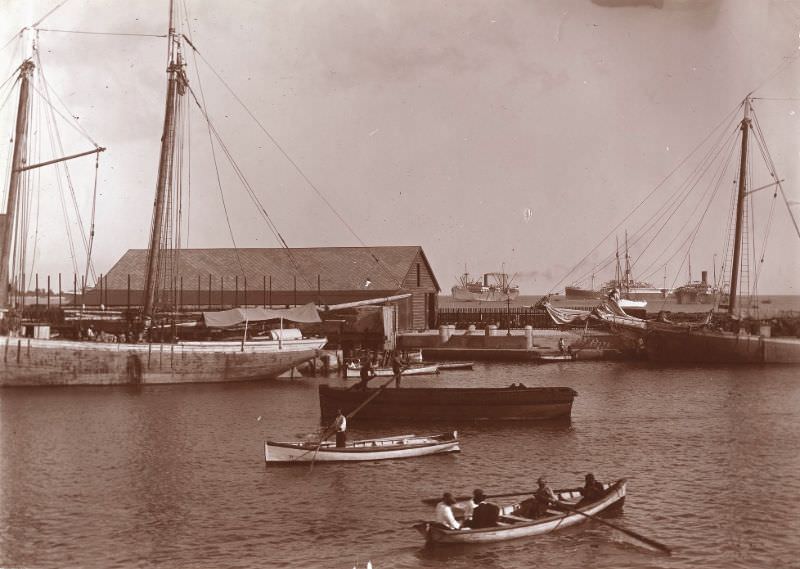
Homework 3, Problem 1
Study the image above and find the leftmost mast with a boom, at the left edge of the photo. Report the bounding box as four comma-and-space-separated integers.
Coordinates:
0, 59, 34, 308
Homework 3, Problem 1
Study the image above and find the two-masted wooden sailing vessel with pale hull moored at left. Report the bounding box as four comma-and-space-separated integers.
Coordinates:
0, 3, 326, 386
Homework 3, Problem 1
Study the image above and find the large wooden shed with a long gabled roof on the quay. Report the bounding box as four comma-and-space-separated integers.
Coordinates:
88, 246, 441, 330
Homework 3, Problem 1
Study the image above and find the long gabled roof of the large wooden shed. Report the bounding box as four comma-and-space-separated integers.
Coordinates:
103, 245, 440, 291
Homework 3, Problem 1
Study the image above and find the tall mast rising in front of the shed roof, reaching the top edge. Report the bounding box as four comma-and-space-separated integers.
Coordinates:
143, 1, 184, 318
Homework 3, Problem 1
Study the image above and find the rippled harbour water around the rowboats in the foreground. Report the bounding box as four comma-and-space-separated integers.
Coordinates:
0, 362, 800, 569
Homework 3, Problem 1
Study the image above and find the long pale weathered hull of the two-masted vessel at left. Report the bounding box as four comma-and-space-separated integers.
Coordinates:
0, 336, 326, 386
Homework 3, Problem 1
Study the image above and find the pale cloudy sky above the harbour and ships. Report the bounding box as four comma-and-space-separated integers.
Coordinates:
0, 0, 800, 294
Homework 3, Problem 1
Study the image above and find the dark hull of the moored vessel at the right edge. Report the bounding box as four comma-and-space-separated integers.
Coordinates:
645, 329, 800, 364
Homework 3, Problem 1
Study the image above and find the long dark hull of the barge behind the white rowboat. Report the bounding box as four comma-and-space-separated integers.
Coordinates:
319, 385, 577, 422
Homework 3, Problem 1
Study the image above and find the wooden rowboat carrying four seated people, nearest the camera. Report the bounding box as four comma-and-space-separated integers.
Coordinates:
414, 478, 627, 543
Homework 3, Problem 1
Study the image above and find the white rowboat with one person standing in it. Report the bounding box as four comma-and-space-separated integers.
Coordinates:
264, 431, 461, 463
